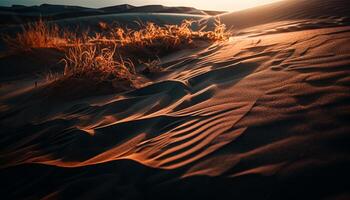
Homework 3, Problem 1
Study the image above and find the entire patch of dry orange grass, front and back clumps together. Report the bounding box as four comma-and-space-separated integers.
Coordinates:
3, 17, 228, 94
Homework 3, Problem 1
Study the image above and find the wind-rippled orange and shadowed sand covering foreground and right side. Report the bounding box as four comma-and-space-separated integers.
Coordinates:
0, 0, 350, 200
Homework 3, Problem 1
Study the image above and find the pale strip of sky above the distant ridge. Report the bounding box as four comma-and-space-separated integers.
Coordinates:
0, 0, 278, 11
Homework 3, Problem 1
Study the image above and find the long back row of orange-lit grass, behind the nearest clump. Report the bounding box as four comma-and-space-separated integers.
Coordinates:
3, 19, 229, 50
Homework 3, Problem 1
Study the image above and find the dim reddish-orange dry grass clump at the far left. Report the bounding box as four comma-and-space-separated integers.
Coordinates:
3, 19, 70, 51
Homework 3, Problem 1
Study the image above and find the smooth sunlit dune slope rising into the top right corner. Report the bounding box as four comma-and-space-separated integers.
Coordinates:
222, 0, 350, 29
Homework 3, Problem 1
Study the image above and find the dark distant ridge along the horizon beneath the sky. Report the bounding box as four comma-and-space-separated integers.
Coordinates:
0, 4, 224, 24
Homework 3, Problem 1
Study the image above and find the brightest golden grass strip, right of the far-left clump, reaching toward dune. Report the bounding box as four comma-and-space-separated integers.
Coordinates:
90, 19, 229, 53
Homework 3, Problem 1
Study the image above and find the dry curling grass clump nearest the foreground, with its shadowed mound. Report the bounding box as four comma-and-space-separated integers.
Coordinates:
48, 43, 136, 100
